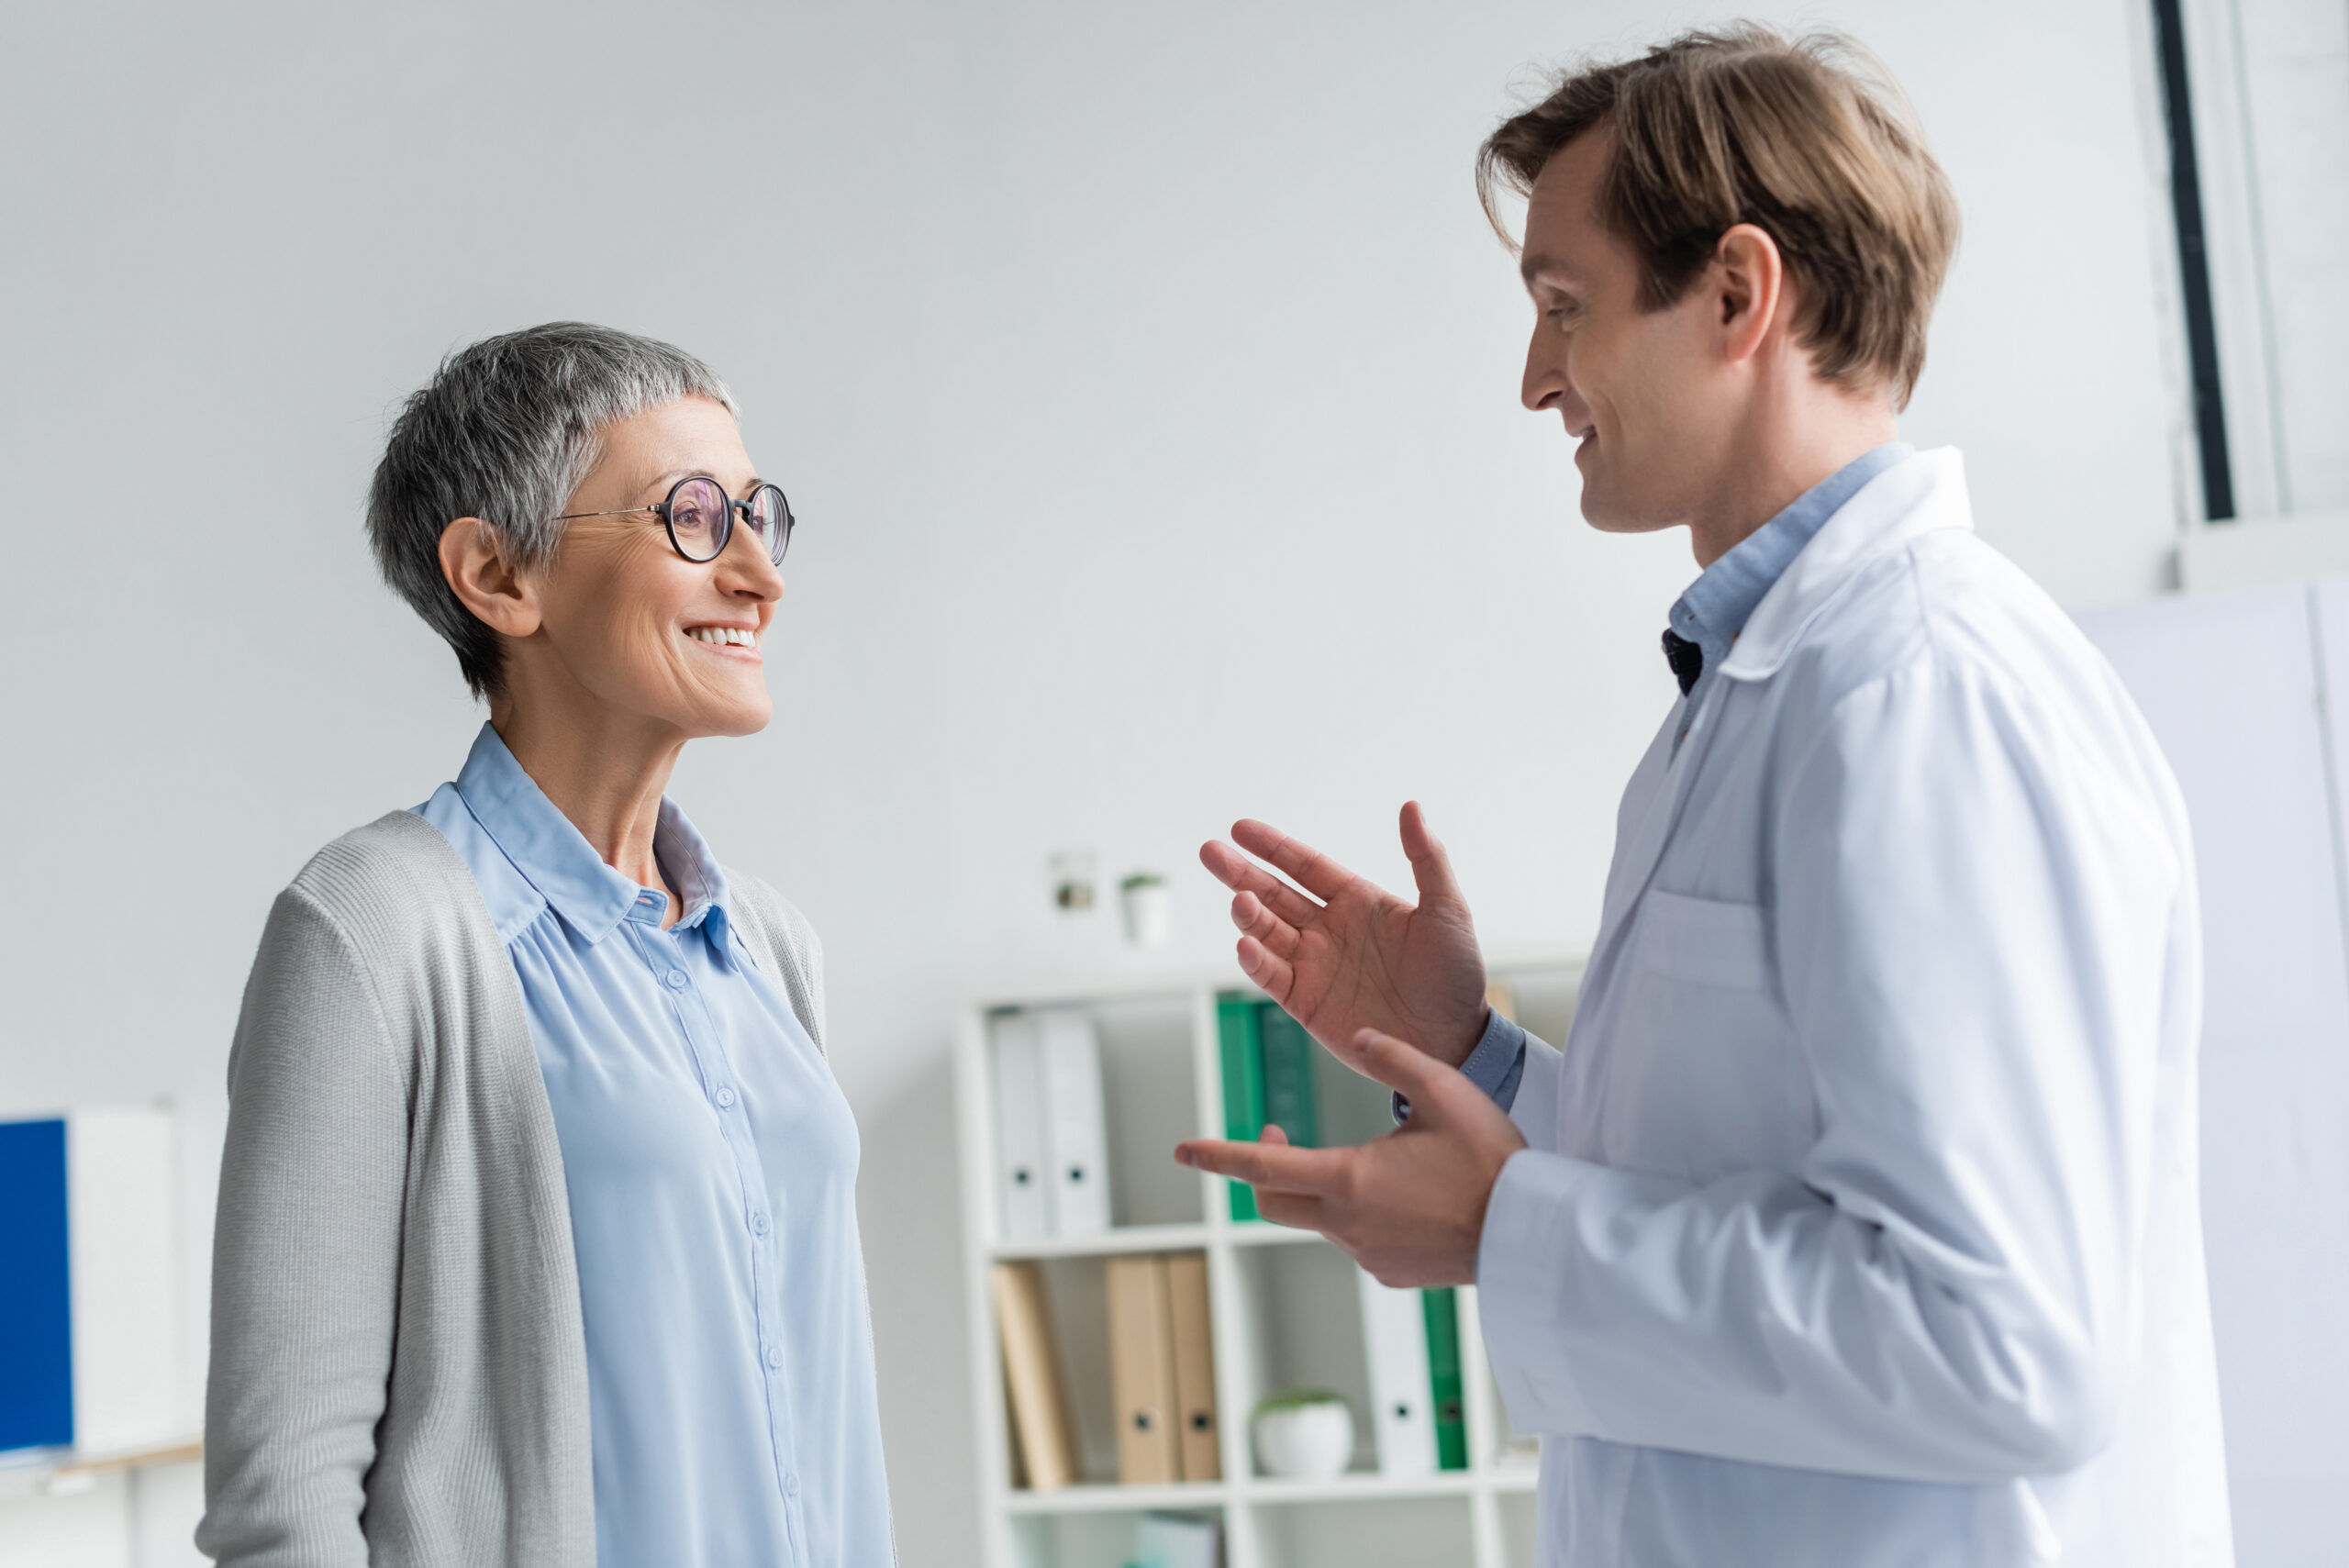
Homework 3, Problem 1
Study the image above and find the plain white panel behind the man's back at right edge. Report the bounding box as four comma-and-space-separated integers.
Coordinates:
2081, 580, 2349, 1568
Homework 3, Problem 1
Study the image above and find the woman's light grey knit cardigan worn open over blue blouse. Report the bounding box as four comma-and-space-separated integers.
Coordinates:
195, 812, 825, 1568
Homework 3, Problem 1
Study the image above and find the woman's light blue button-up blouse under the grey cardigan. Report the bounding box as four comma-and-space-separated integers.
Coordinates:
416, 726, 893, 1568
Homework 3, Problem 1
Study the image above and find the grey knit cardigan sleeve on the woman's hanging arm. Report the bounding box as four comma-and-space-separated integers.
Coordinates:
197, 885, 408, 1568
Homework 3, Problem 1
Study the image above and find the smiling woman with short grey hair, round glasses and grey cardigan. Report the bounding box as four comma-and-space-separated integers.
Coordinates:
197, 321, 893, 1568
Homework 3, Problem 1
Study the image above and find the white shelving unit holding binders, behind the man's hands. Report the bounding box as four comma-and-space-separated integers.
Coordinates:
956, 955, 1581, 1568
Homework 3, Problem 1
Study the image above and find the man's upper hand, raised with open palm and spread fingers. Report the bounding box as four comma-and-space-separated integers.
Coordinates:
1198, 800, 1486, 1066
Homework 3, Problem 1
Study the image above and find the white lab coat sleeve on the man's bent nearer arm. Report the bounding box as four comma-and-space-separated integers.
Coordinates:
1477, 657, 2185, 1484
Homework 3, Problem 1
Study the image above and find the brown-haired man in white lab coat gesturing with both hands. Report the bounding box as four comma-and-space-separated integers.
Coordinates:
1179, 28, 2232, 1568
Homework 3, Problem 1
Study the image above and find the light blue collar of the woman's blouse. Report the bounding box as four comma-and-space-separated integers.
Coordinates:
456, 723, 726, 951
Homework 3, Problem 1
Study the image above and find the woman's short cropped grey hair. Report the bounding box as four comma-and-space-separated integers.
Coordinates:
366, 321, 740, 697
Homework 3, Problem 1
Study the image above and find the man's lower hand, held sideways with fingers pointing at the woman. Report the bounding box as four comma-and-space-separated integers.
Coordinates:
1174, 1029, 1524, 1286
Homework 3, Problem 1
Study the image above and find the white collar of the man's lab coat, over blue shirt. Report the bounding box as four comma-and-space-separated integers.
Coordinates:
1721, 446, 1973, 681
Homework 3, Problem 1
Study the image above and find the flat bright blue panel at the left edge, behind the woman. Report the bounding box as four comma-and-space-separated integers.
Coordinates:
0, 1119, 72, 1453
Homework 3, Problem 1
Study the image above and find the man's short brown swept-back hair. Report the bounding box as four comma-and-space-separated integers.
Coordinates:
1475, 21, 1956, 408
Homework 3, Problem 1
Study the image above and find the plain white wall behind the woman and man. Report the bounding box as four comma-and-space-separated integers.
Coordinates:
0, 0, 2180, 1563
